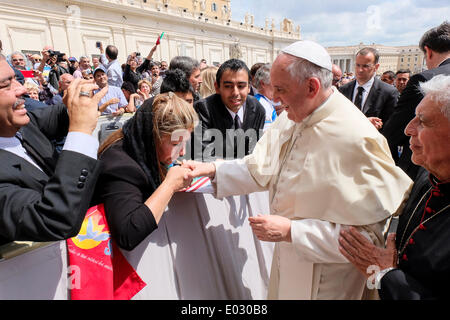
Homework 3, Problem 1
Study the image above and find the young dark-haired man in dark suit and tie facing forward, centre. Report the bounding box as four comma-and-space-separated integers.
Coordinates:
192, 59, 265, 160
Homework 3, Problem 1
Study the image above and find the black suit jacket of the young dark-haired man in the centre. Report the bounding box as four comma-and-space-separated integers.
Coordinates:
191, 94, 266, 160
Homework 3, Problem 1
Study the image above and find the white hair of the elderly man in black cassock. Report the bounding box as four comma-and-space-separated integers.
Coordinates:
419, 74, 450, 120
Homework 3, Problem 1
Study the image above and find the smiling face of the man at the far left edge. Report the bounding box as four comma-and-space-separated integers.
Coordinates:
0, 60, 30, 137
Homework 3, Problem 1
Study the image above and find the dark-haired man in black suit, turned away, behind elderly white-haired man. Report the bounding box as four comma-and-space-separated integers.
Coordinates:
383, 22, 450, 179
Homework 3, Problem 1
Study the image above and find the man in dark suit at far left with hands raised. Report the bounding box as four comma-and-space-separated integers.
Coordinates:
0, 55, 106, 244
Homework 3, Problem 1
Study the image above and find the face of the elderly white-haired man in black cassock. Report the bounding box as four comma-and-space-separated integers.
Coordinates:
405, 96, 450, 179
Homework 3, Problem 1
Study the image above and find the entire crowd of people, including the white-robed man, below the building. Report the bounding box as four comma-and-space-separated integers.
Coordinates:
0, 22, 450, 299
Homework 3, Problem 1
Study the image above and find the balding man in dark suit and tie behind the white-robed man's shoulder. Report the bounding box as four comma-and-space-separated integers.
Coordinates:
339, 47, 398, 133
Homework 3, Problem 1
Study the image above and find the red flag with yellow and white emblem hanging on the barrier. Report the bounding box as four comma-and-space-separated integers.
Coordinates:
67, 204, 146, 300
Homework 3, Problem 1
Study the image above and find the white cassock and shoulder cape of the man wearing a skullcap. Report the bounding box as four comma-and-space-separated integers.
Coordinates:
213, 87, 412, 299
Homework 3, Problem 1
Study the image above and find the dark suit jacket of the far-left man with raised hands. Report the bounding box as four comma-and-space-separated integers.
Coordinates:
0, 105, 98, 244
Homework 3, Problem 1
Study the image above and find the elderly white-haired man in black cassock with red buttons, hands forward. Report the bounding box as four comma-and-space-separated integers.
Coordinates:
339, 75, 450, 300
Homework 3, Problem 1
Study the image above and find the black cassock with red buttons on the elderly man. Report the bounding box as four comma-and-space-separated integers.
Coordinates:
379, 168, 450, 300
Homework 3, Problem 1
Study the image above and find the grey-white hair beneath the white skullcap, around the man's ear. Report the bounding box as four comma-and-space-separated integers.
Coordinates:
281, 53, 333, 89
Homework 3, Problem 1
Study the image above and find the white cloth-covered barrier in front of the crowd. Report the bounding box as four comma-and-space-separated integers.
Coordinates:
0, 192, 273, 300
